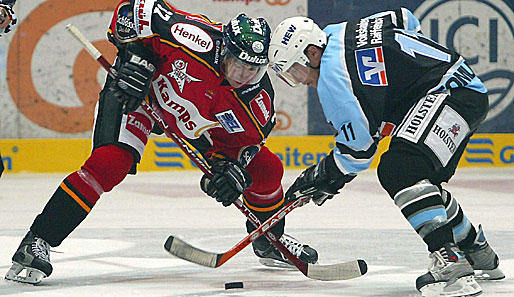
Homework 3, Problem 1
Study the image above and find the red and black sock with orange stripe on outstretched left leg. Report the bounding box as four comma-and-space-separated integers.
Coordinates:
30, 145, 134, 246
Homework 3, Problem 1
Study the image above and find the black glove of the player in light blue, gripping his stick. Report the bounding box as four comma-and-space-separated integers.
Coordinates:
285, 151, 355, 206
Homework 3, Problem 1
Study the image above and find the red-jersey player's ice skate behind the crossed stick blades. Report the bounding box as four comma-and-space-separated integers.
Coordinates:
253, 234, 318, 268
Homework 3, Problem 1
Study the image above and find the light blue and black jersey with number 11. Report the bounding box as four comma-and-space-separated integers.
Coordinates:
317, 8, 487, 174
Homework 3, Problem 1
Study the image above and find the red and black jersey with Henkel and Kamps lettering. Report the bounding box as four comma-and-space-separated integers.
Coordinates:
109, 0, 275, 158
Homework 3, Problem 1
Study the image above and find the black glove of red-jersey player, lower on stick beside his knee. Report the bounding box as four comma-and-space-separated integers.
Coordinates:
200, 159, 252, 206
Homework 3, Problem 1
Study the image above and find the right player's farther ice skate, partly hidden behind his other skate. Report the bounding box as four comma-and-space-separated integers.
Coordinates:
462, 225, 505, 280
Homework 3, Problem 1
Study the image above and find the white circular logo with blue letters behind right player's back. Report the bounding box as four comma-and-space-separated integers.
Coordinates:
414, 0, 514, 128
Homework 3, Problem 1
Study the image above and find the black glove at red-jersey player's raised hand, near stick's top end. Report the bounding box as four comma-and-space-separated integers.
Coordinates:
109, 44, 155, 113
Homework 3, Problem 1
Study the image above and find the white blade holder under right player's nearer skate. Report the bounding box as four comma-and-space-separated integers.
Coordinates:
420, 275, 482, 297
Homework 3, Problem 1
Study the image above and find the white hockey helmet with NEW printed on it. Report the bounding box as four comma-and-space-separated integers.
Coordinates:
268, 16, 327, 87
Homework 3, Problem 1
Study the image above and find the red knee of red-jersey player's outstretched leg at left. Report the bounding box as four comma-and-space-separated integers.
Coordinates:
82, 145, 134, 192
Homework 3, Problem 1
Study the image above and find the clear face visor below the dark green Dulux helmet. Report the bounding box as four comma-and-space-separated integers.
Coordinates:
223, 50, 268, 88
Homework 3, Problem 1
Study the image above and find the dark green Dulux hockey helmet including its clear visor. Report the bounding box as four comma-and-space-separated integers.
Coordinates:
222, 13, 271, 84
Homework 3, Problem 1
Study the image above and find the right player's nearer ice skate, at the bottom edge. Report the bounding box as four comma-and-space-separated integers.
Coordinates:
416, 244, 482, 297
